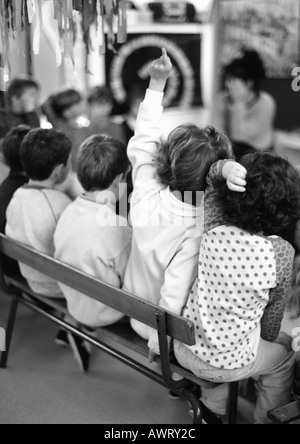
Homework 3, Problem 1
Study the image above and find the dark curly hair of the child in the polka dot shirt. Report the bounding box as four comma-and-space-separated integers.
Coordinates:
216, 152, 300, 236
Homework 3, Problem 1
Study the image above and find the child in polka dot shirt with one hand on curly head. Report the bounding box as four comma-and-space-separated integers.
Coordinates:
175, 153, 300, 424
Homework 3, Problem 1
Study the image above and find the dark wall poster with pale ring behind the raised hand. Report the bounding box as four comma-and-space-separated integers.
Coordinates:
106, 33, 202, 108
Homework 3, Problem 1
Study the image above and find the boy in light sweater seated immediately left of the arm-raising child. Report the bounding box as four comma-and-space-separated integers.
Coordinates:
55, 135, 131, 328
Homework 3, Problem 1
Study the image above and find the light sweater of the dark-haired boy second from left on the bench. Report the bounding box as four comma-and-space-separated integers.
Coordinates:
5, 185, 71, 298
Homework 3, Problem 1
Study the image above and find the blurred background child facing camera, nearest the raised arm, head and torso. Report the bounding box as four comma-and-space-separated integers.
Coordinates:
88, 86, 127, 144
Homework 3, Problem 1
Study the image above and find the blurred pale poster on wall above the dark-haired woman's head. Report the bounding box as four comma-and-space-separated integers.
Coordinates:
221, 0, 300, 78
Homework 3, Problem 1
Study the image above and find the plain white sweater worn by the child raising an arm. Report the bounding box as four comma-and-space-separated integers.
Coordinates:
124, 90, 203, 353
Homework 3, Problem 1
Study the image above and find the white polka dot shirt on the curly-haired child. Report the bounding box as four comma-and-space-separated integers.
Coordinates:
184, 225, 277, 370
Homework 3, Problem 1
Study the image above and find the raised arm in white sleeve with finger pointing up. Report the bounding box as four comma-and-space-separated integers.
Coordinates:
128, 49, 172, 191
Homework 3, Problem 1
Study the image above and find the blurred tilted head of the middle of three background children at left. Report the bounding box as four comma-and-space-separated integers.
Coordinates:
51, 89, 84, 120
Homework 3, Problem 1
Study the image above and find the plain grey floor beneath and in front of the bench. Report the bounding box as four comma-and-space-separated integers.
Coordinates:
0, 294, 253, 424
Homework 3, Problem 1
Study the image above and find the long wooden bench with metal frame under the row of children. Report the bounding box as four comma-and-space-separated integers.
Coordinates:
0, 235, 239, 424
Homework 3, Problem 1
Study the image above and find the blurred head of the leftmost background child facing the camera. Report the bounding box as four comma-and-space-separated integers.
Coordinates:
7, 76, 40, 128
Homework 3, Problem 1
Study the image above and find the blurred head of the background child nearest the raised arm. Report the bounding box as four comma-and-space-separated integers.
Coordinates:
88, 86, 114, 120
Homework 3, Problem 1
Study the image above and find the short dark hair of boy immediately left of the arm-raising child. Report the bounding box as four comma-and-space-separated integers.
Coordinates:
77, 135, 129, 191
